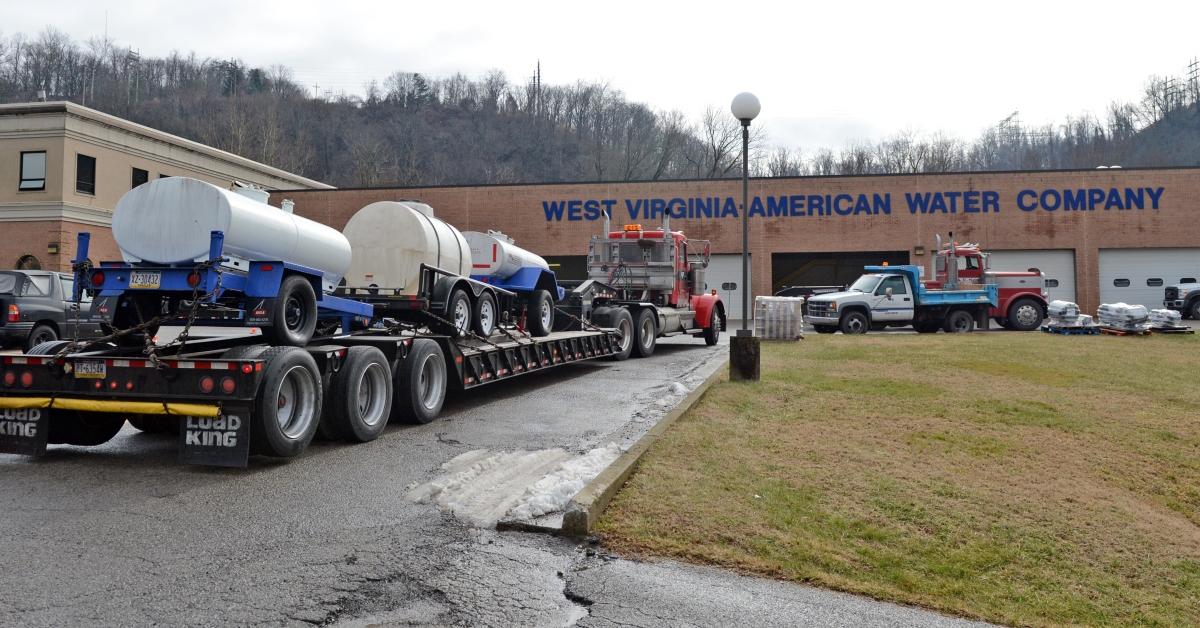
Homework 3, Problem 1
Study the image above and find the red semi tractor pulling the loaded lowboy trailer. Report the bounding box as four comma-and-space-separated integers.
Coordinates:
559, 215, 726, 359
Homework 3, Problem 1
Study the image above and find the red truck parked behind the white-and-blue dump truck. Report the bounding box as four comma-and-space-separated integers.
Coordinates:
925, 237, 1046, 331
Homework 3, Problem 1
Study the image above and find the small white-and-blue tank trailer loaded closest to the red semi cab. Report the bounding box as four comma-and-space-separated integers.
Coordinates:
462, 231, 566, 336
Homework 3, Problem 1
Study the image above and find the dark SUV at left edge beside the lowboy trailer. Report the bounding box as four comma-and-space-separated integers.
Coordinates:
0, 270, 102, 351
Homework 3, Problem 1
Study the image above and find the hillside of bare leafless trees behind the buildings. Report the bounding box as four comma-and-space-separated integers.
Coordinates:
0, 29, 1200, 187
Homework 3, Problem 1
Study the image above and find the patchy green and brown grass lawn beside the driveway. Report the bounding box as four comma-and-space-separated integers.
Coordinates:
600, 333, 1200, 626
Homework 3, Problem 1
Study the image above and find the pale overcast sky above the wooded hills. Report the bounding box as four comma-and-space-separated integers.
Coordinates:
0, 0, 1200, 152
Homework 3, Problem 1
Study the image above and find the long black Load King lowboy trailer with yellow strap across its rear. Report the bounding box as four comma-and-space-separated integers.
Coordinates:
0, 329, 620, 467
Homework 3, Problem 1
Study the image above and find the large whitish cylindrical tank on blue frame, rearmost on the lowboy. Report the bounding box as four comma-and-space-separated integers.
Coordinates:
113, 177, 350, 291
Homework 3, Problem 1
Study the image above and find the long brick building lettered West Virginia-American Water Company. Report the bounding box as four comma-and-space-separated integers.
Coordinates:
272, 168, 1200, 313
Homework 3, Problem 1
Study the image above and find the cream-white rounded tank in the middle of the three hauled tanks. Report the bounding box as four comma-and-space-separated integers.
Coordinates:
342, 201, 470, 294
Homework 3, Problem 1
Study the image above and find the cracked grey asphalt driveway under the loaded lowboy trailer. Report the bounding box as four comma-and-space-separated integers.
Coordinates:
0, 337, 984, 626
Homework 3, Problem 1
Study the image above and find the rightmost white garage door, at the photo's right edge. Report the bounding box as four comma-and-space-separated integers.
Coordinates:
1100, 249, 1200, 309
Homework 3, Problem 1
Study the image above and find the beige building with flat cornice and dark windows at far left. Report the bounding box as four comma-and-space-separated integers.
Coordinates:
0, 102, 331, 270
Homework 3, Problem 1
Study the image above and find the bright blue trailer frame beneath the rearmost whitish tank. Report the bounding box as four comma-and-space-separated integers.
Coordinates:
72, 231, 374, 329
